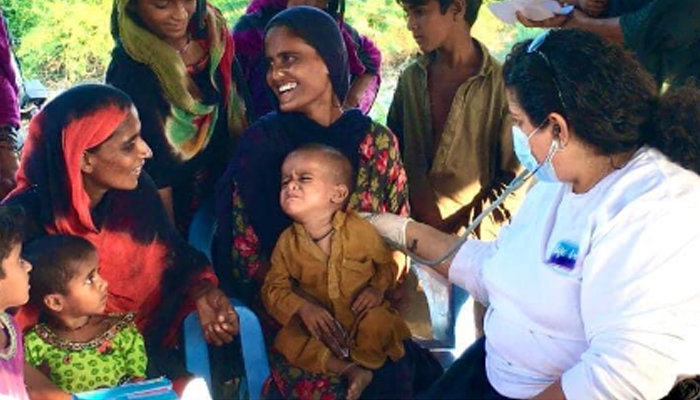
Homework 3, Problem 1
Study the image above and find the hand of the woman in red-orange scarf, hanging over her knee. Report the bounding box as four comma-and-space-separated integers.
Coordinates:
195, 285, 239, 346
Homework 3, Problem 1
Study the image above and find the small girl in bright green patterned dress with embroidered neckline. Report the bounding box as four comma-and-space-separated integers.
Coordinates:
24, 235, 146, 393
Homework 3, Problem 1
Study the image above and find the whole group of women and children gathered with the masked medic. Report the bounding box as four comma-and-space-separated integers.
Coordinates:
0, 0, 700, 400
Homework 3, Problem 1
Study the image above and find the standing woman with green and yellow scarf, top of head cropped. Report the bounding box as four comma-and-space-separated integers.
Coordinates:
106, 0, 246, 232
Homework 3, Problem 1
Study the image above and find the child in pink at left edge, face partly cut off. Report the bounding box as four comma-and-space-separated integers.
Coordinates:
0, 206, 32, 400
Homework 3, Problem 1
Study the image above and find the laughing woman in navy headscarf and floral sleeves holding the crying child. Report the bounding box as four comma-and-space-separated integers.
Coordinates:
215, 6, 441, 398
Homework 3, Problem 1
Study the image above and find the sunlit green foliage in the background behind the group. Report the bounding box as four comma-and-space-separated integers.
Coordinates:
2, 0, 536, 114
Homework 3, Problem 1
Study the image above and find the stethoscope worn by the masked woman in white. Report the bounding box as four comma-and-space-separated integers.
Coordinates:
396, 140, 559, 267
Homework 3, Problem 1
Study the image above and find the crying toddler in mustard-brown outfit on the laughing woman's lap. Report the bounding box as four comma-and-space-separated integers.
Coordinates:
262, 145, 410, 400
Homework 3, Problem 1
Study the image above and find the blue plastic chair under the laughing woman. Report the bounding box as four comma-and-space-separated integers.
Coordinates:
184, 199, 270, 399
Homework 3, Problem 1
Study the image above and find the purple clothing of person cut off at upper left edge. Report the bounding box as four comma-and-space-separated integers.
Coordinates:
0, 11, 19, 127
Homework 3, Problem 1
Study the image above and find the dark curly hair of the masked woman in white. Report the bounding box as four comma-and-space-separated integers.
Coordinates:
503, 29, 700, 172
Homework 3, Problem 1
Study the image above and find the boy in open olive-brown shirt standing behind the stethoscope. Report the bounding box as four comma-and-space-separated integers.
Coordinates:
387, 0, 519, 336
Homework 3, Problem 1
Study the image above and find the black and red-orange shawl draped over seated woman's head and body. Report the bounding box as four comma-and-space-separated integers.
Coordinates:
6, 85, 217, 343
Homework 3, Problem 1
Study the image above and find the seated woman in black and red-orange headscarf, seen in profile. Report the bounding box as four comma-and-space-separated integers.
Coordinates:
6, 85, 238, 398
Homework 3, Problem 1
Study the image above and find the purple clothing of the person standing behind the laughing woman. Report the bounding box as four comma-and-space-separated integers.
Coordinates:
233, 0, 382, 120
